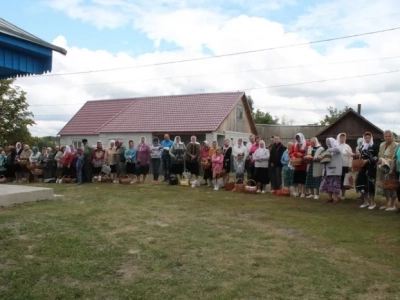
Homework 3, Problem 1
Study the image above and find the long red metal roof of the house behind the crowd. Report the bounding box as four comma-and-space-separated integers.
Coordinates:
59, 92, 244, 135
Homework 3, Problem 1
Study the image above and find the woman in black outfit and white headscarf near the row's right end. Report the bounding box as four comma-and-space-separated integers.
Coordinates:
356, 132, 379, 210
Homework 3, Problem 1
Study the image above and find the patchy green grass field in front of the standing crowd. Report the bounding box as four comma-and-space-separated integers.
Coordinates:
0, 184, 400, 300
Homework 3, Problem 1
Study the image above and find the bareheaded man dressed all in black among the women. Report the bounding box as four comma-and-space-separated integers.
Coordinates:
269, 136, 286, 192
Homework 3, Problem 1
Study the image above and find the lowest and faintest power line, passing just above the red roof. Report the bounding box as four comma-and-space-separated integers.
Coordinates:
30, 70, 400, 107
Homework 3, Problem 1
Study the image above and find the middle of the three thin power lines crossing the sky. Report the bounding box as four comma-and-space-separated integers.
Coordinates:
22, 55, 400, 90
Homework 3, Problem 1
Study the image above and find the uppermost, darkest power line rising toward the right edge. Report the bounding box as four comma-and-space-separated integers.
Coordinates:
31, 27, 400, 78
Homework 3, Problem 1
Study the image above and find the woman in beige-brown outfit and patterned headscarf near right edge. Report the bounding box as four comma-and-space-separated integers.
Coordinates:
376, 130, 397, 211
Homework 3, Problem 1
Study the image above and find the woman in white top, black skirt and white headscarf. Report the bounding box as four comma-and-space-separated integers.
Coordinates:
252, 141, 270, 194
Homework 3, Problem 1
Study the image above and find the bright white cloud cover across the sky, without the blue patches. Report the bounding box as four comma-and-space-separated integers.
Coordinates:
17, 0, 400, 135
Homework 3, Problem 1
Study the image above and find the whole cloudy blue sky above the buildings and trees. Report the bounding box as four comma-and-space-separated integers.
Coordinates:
0, 0, 400, 136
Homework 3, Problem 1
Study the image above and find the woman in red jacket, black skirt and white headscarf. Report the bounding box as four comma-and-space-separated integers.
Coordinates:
289, 133, 310, 198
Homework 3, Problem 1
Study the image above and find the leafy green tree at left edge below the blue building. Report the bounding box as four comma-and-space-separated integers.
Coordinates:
0, 79, 35, 145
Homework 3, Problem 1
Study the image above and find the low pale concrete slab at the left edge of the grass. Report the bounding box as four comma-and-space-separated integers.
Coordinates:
0, 184, 55, 206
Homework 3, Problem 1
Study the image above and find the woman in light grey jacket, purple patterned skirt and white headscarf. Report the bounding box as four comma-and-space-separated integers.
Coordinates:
318, 138, 343, 204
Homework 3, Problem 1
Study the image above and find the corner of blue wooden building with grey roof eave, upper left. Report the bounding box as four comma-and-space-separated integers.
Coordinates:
0, 18, 67, 79
